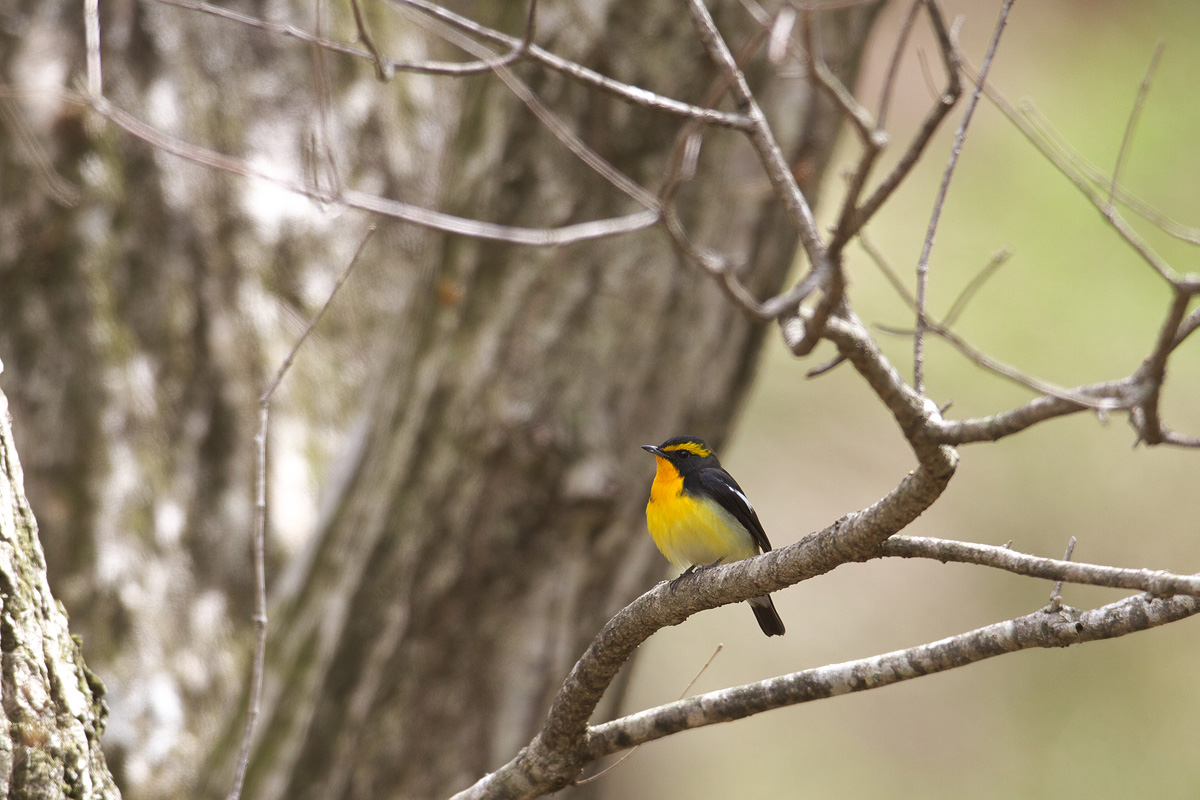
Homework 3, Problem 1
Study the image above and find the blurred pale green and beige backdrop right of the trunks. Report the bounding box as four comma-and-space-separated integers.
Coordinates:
604, 1, 1200, 800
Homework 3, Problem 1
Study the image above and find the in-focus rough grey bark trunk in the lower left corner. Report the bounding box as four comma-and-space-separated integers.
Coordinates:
0, 371, 121, 800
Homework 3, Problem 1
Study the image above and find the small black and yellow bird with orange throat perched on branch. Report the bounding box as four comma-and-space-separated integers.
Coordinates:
642, 437, 784, 636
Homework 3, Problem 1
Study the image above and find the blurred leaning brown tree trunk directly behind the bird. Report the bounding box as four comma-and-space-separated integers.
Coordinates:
211, 2, 871, 799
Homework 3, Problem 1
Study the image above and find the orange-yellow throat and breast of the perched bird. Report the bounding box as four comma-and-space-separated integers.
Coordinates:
646, 458, 758, 570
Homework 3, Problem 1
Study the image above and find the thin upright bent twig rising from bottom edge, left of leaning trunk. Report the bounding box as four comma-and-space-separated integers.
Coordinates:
226, 225, 376, 800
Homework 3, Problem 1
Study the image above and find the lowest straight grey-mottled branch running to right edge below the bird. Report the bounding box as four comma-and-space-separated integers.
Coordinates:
582, 595, 1200, 760
